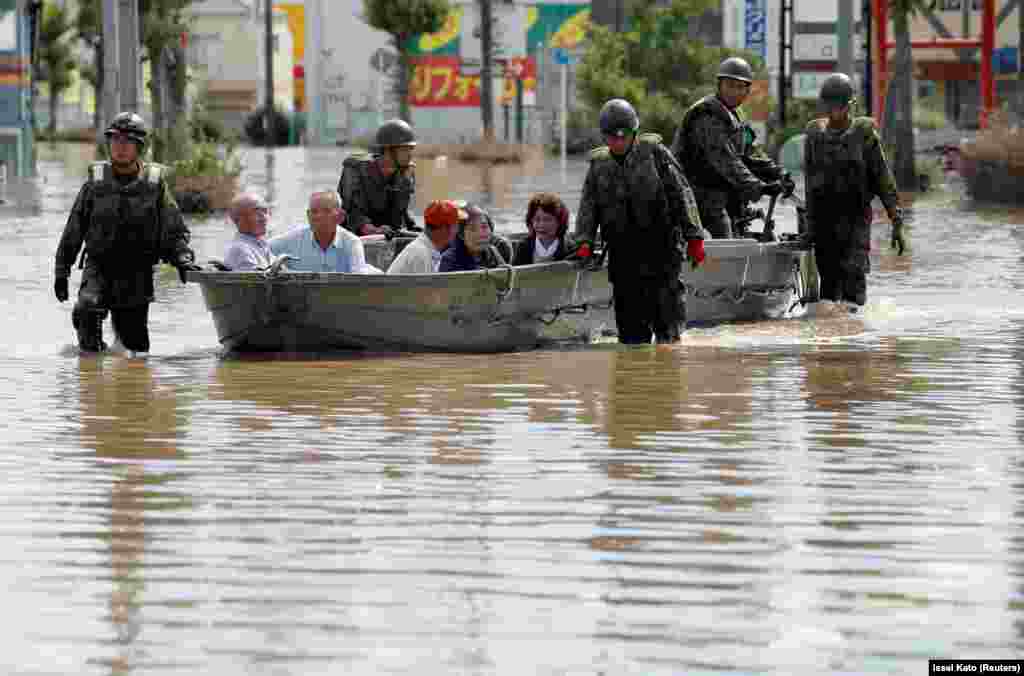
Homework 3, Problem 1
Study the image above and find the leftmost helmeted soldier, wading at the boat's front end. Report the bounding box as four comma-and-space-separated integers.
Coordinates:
53, 113, 200, 353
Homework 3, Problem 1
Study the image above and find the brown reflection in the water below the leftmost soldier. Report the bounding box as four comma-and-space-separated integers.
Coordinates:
78, 357, 189, 674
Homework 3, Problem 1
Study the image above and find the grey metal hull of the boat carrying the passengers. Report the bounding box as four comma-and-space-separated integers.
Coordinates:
189, 240, 817, 351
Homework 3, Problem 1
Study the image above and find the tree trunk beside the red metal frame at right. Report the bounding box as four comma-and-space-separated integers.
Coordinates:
883, 0, 935, 189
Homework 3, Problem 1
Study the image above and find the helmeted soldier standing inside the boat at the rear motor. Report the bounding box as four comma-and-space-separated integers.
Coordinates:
672, 56, 794, 238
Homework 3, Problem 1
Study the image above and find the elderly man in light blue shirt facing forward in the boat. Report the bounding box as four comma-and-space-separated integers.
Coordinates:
269, 191, 372, 273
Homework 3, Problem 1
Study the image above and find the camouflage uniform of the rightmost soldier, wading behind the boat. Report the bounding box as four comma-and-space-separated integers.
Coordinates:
804, 118, 902, 305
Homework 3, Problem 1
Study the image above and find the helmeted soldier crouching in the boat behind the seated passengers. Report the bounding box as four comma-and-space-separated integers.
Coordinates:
338, 119, 420, 236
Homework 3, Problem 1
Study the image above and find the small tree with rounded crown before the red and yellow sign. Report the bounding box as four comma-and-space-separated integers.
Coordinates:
362, 0, 452, 122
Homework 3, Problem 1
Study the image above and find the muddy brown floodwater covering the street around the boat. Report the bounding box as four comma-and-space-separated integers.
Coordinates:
0, 142, 1024, 676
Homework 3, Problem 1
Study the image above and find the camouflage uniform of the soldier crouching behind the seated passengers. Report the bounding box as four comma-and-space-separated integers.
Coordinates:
338, 153, 420, 235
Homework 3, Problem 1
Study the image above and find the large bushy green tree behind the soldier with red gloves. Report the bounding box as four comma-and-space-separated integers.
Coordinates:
577, 0, 762, 142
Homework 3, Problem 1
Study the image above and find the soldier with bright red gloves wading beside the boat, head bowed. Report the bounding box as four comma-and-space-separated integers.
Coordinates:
570, 98, 703, 344
